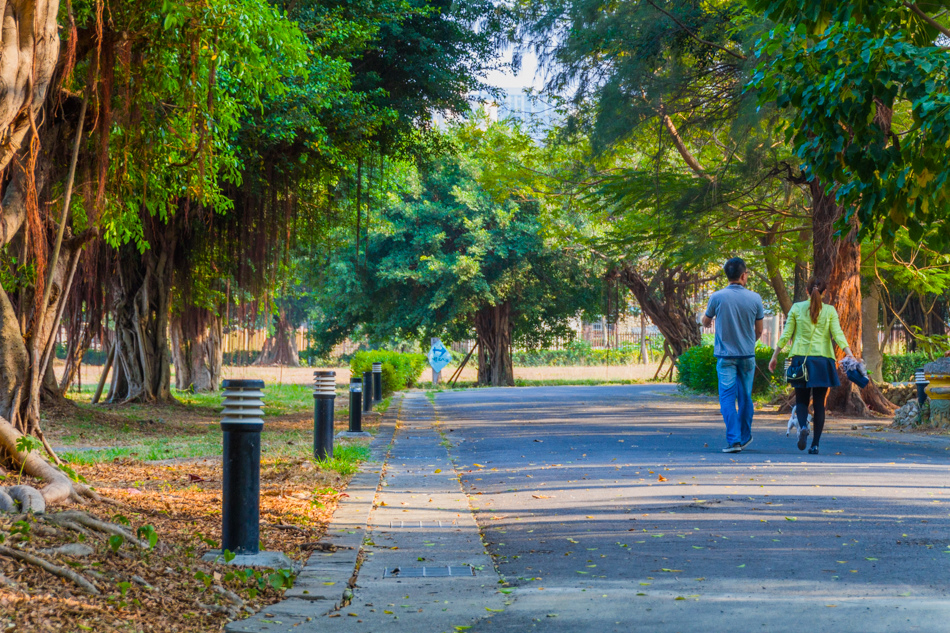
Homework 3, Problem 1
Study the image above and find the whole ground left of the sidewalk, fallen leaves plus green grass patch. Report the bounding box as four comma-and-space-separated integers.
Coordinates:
0, 370, 378, 633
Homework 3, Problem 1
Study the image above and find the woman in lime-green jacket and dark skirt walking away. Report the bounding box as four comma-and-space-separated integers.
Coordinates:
769, 277, 854, 455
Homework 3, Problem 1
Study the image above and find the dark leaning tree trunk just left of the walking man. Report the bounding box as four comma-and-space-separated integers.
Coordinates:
620, 264, 702, 358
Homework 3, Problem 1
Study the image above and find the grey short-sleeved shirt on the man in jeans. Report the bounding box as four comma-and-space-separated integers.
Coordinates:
706, 284, 765, 358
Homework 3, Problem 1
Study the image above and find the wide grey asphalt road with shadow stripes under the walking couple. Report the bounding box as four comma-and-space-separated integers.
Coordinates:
436, 385, 950, 633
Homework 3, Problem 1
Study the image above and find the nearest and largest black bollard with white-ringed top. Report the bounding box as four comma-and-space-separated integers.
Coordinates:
221, 380, 264, 554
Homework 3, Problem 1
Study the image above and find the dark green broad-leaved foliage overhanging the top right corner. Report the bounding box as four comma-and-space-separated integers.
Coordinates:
752, 0, 950, 246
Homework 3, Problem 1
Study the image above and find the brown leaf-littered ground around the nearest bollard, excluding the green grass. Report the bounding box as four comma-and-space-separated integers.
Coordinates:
0, 400, 372, 633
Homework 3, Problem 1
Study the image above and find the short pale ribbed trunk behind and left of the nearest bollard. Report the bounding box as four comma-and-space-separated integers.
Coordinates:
170, 306, 224, 391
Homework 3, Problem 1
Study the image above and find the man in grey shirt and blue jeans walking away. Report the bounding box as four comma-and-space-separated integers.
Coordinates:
703, 257, 765, 453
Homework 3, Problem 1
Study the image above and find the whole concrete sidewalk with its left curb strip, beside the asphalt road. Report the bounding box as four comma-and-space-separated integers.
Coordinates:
227, 392, 506, 633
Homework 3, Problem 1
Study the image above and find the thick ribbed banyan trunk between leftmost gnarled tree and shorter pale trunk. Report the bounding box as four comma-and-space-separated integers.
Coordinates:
106, 223, 175, 403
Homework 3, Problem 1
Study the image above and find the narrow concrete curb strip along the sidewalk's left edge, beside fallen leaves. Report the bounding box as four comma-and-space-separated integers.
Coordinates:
224, 392, 405, 633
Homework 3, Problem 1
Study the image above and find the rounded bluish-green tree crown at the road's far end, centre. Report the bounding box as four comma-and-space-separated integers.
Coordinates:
313, 123, 600, 353
